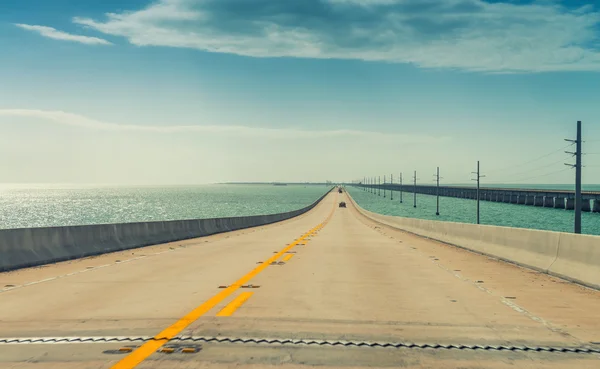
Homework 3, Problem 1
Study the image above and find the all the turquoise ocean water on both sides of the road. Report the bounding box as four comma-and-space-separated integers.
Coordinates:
0, 184, 600, 235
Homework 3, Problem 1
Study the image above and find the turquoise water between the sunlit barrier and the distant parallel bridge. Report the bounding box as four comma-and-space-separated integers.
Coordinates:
348, 185, 600, 235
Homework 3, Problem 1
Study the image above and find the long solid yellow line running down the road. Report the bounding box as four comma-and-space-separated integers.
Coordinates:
111, 196, 337, 369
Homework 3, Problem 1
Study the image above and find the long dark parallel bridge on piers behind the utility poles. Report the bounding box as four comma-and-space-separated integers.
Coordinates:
358, 183, 600, 213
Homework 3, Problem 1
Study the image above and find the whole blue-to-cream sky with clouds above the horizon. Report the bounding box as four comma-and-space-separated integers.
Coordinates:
0, 0, 600, 185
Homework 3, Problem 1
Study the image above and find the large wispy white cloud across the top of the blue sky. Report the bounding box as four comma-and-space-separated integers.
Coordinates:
64, 0, 600, 72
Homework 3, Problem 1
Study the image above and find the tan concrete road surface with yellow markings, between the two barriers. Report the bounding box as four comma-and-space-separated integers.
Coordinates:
0, 193, 600, 369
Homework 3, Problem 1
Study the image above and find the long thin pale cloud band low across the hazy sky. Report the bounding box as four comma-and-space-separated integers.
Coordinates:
0, 109, 449, 144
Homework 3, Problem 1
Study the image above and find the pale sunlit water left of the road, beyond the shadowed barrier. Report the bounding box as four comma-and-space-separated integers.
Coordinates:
0, 185, 331, 229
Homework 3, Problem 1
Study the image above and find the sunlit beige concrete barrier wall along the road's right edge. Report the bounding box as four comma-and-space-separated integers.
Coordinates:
349, 196, 600, 289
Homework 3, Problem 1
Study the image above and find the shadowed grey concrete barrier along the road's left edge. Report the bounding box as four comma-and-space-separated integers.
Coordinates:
0, 191, 330, 272
